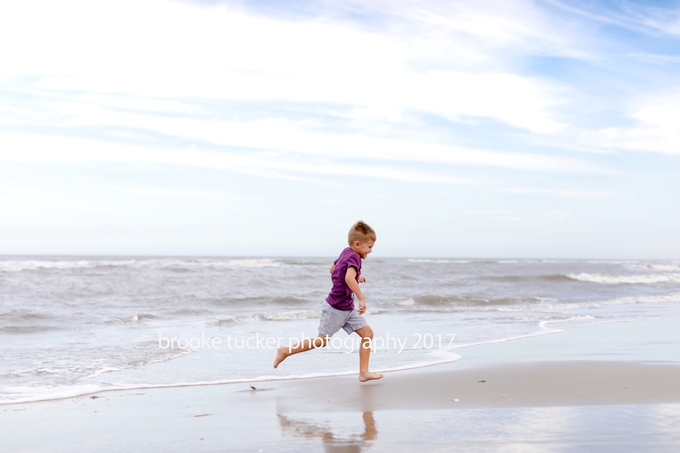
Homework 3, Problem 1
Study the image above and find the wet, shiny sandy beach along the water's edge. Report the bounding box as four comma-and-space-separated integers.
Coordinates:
5, 319, 680, 452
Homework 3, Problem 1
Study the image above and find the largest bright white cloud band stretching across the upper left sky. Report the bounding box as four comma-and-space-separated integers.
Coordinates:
0, 0, 565, 133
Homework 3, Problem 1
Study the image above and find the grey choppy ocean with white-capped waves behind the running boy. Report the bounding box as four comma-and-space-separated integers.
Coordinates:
0, 256, 680, 404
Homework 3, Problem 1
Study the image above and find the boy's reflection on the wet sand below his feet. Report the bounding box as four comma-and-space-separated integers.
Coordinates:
277, 412, 378, 453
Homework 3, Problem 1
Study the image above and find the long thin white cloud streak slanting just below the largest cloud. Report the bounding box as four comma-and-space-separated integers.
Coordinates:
14, 98, 600, 172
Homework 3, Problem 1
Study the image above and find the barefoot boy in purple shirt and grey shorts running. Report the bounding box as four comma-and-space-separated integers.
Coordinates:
274, 220, 383, 382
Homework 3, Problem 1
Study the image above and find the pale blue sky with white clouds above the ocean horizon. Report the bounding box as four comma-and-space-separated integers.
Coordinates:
0, 0, 680, 259
